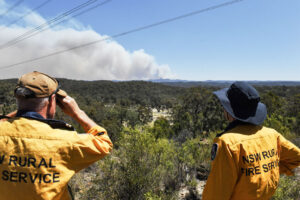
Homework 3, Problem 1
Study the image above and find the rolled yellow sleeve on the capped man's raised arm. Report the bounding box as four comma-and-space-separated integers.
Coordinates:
69, 126, 113, 172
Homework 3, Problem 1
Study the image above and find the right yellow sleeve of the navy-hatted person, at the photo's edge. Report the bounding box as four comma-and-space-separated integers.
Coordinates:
277, 134, 300, 176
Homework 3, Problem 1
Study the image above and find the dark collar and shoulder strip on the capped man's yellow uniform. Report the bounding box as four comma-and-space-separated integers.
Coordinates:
16, 110, 75, 131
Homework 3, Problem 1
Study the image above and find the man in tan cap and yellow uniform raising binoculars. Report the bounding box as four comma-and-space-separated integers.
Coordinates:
0, 72, 112, 200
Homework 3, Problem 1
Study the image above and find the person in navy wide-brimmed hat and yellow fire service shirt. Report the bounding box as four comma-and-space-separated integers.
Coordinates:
202, 82, 300, 200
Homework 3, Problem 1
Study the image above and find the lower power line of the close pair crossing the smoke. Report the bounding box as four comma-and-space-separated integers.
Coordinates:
0, 0, 112, 47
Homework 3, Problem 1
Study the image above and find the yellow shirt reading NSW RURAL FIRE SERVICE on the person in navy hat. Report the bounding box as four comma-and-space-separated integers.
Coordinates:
202, 124, 300, 200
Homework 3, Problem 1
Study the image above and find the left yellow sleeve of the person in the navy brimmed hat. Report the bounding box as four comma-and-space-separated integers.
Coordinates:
202, 138, 238, 200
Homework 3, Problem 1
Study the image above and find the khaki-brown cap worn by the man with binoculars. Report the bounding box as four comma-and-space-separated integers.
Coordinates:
16, 71, 67, 98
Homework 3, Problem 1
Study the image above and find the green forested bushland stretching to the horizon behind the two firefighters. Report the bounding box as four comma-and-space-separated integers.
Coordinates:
0, 79, 300, 199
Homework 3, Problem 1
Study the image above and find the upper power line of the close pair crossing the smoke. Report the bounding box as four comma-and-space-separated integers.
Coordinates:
0, 0, 98, 49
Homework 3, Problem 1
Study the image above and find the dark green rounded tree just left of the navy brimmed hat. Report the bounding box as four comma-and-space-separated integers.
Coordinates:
173, 87, 225, 137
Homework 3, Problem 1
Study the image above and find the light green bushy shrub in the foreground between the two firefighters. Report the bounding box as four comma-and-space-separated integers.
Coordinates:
86, 129, 179, 200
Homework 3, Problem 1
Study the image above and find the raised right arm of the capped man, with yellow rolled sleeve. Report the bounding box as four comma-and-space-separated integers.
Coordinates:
57, 96, 113, 172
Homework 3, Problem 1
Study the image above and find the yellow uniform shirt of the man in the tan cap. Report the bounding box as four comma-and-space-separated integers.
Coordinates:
0, 117, 112, 200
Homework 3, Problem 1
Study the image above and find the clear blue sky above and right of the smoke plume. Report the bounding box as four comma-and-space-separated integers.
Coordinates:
0, 0, 300, 81
